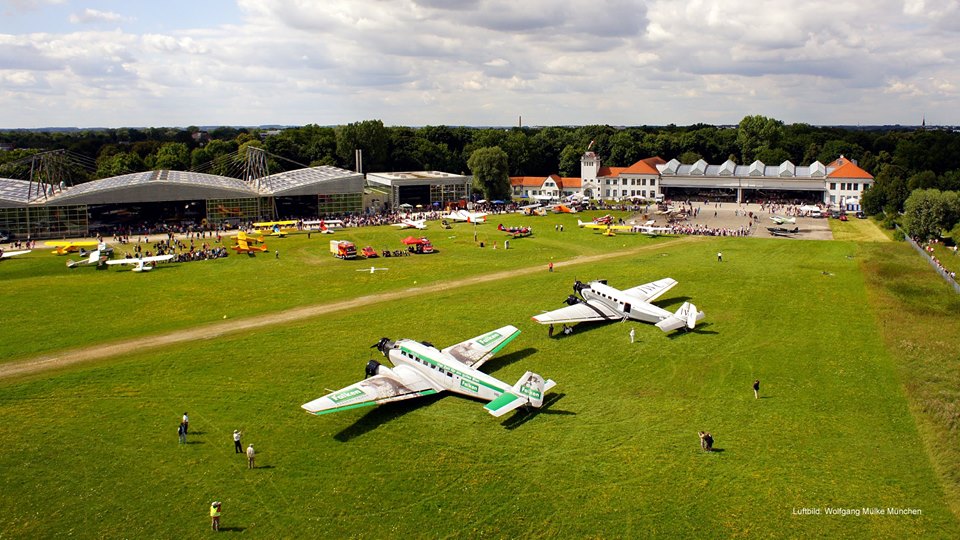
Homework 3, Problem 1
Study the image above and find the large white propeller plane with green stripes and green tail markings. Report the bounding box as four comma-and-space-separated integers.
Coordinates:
302, 326, 556, 416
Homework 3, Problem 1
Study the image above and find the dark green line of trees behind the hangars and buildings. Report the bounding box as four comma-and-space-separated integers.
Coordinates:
0, 115, 960, 239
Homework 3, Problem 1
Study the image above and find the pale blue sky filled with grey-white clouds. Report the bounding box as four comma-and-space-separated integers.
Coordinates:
0, 0, 960, 128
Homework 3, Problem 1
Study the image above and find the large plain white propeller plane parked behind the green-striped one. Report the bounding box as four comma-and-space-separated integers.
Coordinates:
533, 278, 704, 332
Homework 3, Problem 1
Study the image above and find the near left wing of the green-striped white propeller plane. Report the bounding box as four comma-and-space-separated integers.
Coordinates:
301, 366, 437, 415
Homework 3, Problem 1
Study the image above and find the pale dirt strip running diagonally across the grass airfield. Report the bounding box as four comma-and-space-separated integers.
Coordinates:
0, 236, 700, 379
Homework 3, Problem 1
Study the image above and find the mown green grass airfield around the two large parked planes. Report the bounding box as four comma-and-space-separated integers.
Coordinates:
0, 217, 960, 538
